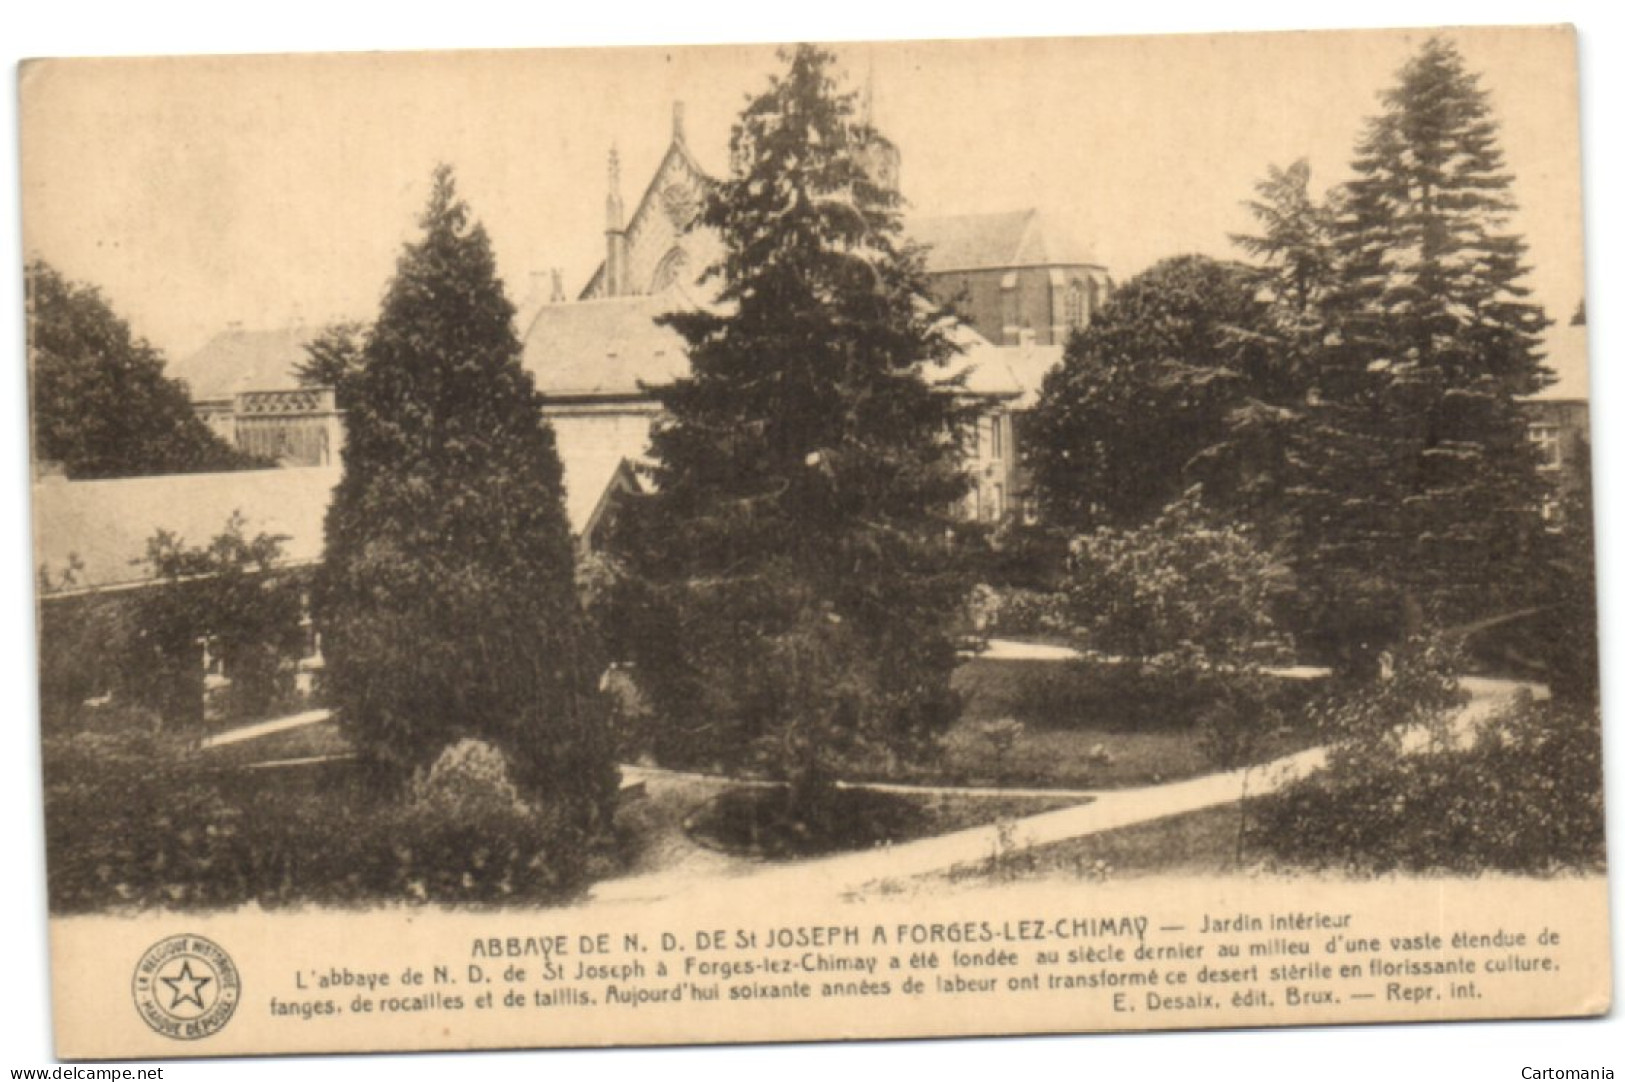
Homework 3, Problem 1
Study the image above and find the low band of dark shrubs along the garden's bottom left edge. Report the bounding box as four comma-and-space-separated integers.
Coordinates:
46, 726, 588, 913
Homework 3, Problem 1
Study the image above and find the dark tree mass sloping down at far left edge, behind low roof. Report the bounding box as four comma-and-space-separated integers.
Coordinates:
26, 260, 265, 479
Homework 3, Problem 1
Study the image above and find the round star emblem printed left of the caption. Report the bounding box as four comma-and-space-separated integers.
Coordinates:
132, 934, 242, 1041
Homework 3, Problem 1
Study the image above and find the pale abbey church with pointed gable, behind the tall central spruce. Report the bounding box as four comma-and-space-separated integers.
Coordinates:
520, 104, 1110, 522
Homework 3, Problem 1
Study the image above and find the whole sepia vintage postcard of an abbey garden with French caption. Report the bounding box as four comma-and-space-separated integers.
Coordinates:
18, 28, 1612, 1059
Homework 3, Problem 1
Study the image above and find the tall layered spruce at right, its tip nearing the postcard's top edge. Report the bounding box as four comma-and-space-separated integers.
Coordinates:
1292, 39, 1549, 666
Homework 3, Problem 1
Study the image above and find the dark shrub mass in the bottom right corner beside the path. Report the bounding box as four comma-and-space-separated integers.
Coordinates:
1248, 645, 1604, 874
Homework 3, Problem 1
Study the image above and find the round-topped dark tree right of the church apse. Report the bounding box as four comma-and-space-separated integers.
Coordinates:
1025, 255, 1292, 530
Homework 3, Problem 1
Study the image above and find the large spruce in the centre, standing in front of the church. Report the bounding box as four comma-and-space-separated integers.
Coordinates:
618, 45, 972, 820
